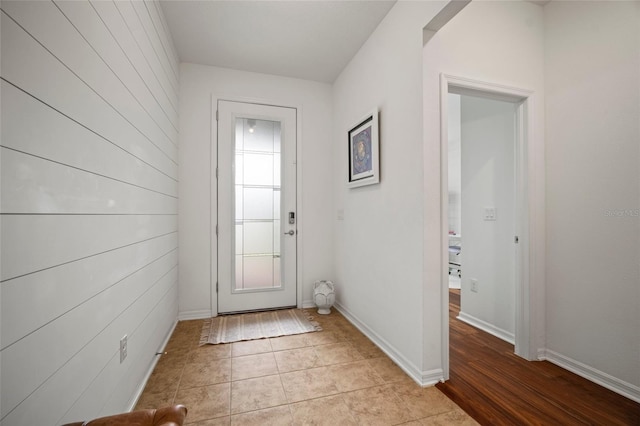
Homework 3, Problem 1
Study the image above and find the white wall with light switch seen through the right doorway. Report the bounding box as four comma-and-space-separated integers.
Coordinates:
460, 96, 516, 343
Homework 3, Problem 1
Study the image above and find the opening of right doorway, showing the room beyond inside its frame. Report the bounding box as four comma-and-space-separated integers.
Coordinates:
448, 92, 517, 344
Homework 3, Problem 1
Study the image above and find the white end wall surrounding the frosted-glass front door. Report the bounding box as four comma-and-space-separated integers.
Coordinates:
179, 63, 334, 318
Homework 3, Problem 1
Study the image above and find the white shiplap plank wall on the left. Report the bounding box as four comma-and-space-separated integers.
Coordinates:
0, 0, 179, 426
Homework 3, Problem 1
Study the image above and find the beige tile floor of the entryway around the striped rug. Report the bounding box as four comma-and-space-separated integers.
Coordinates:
136, 310, 477, 426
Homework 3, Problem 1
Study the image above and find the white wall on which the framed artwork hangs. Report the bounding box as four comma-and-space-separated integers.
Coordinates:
332, 2, 444, 383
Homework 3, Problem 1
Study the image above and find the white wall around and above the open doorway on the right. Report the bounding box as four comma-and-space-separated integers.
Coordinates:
423, 1, 545, 368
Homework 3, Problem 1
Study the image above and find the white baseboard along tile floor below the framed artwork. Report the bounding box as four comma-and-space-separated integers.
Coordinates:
334, 302, 444, 386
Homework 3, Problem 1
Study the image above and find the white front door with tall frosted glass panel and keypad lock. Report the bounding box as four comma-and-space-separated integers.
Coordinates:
217, 101, 298, 313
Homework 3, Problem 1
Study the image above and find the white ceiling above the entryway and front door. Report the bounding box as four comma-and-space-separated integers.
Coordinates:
160, 0, 395, 83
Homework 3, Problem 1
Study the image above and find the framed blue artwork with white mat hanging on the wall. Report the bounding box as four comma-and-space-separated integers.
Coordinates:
347, 110, 380, 188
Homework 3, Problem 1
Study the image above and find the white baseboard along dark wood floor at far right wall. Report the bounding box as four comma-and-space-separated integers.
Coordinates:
538, 349, 640, 403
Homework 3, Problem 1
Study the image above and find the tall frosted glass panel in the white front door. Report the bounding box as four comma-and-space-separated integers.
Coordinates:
234, 118, 281, 291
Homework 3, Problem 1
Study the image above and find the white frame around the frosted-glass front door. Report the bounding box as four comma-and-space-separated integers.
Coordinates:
209, 93, 305, 317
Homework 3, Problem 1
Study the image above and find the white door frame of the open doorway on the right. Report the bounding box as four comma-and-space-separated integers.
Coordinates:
440, 73, 545, 380
